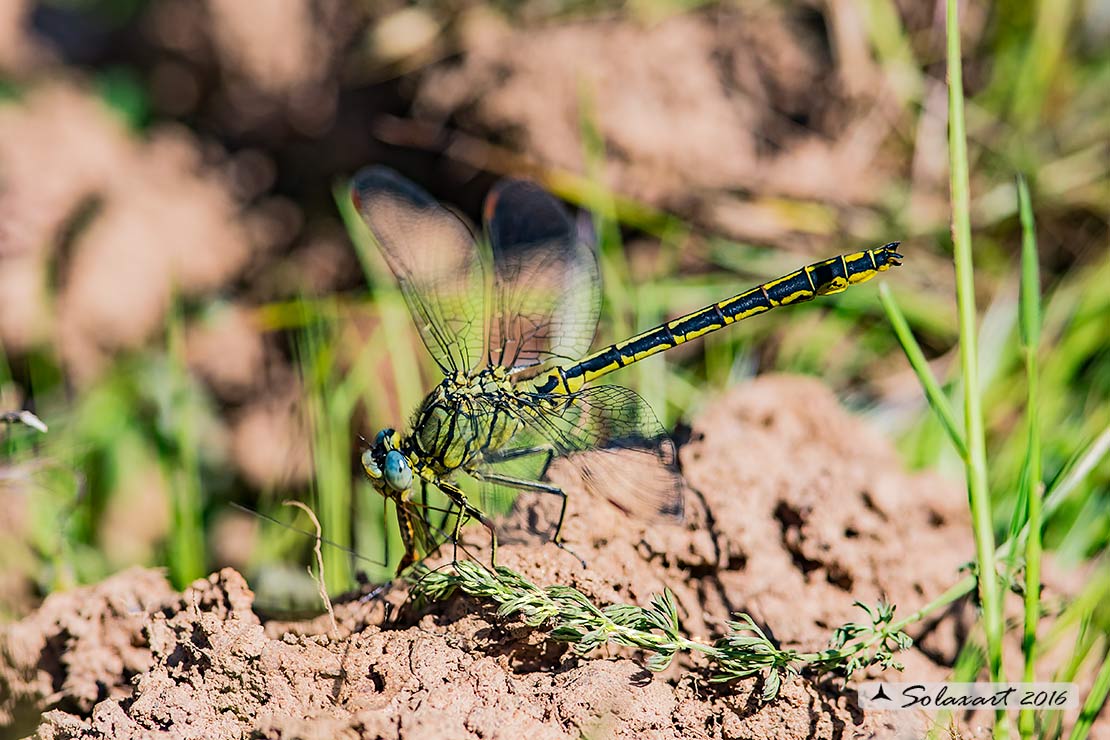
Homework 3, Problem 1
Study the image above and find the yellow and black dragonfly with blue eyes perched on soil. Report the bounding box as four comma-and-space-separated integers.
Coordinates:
350, 165, 902, 574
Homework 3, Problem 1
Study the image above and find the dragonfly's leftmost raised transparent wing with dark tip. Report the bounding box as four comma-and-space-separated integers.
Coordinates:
351, 166, 485, 374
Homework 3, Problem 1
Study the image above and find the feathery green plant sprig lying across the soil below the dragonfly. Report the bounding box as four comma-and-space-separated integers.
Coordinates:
411, 560, 936, 701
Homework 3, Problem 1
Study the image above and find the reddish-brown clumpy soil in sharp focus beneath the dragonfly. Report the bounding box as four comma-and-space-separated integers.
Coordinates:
0, 377, 990, 740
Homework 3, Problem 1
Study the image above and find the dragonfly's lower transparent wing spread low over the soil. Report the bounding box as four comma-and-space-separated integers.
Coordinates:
484, 385, 683, 520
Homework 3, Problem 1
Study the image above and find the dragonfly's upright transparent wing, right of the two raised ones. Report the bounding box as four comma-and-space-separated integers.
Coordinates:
485, 180, 601, 371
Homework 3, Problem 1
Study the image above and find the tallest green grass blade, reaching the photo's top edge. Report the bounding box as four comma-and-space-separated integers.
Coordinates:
946, 0, 1006, 705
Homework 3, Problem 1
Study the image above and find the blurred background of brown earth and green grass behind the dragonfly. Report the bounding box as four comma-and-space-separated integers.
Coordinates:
0, 0, 1110, 619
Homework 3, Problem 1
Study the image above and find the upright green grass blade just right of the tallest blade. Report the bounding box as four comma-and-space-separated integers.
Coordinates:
1018, 178, 1045, 738
